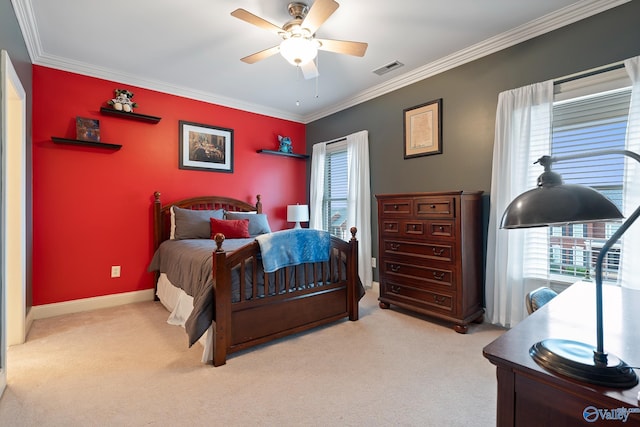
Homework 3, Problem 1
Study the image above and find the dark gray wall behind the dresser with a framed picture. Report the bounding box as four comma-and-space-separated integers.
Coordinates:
307, 1, 640, 278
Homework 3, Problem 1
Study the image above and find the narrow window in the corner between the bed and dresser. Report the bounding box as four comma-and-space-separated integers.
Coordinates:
322, 142, 349, 240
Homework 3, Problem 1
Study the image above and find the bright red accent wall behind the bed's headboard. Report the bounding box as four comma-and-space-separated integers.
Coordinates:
33, 66, 306, 305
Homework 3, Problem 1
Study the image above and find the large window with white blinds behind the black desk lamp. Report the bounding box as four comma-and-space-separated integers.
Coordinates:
548, 72, 631, 282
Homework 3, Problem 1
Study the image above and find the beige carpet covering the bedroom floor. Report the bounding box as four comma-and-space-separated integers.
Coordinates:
0, 292, 502, 426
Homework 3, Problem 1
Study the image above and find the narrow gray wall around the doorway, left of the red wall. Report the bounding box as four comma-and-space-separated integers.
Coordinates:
0, 0, 33, 308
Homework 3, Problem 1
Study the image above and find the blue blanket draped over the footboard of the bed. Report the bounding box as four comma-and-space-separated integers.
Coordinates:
256, 228, 331, 273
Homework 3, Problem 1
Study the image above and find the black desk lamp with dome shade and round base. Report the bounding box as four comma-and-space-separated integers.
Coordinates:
501, 150, 640, 388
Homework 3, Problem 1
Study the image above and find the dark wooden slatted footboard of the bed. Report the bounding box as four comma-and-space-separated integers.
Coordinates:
213, 227, 360, 366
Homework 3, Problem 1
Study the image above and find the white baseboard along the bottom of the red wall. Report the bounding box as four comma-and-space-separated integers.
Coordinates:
29, 289, 153, 320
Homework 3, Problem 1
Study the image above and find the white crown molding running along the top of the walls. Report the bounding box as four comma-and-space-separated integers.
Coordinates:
11, 0, 631, 124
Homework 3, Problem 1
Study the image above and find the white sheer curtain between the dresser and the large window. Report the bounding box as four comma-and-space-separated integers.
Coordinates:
485, 81, 553, 327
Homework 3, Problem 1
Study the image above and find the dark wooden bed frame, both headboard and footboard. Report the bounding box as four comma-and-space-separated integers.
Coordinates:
153, 192, 360, 366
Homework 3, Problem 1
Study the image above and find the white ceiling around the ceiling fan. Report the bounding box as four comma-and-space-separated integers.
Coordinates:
12, 0, 629, 123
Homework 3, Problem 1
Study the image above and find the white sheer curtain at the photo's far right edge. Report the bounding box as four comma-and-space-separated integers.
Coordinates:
621, 56, 640, 289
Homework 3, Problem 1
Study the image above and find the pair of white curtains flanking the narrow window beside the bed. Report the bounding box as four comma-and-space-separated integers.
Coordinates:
309, 131, 372, 288
